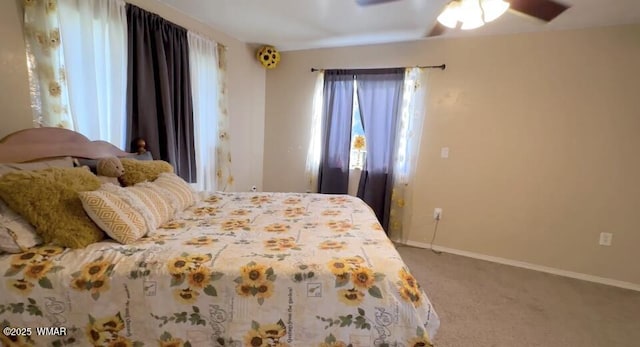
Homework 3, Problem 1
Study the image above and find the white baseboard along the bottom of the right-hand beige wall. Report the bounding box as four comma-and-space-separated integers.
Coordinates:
394, 240, 640, 292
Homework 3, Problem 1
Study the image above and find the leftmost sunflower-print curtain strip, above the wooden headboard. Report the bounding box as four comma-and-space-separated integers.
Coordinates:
24, 0, 74, 129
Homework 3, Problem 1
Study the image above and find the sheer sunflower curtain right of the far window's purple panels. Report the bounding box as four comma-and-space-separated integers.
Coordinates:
389, 68, 427, 241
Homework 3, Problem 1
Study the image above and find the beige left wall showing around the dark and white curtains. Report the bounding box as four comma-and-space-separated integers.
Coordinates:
0, 0, 265, 191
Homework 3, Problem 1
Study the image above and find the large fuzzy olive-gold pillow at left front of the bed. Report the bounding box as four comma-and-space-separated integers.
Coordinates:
0, 168, 104, 248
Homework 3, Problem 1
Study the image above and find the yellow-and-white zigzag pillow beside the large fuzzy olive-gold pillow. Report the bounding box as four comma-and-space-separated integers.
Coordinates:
78, 185, 148, 244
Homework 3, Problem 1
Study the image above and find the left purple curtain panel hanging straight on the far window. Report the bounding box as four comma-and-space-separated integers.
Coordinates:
318, 70, 353, 194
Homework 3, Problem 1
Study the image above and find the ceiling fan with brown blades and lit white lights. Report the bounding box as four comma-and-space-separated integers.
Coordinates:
356, 0, 569, 37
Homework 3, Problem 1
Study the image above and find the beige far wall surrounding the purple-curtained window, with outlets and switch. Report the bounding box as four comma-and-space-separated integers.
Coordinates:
264, 25, 640, 284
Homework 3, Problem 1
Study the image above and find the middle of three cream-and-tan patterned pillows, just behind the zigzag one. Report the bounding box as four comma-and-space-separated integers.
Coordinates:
102, 184, 176, 231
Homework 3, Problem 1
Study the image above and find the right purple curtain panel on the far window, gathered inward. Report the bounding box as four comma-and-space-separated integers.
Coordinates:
355, 68, 404, 230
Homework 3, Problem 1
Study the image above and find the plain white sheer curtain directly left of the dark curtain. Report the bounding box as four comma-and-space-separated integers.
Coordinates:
58, 0, 127, 148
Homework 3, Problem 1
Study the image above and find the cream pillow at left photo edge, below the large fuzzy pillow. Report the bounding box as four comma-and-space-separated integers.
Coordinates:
0, 200, 42, 253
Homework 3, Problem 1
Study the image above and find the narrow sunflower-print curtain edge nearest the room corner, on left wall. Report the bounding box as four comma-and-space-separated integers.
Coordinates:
216, 45, 234, 191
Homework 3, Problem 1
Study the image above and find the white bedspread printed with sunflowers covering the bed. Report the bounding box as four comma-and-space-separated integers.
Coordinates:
0, 193, 439, 347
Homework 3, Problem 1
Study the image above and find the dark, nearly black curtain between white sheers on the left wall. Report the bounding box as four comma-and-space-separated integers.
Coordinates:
127, 4, 196, 182
